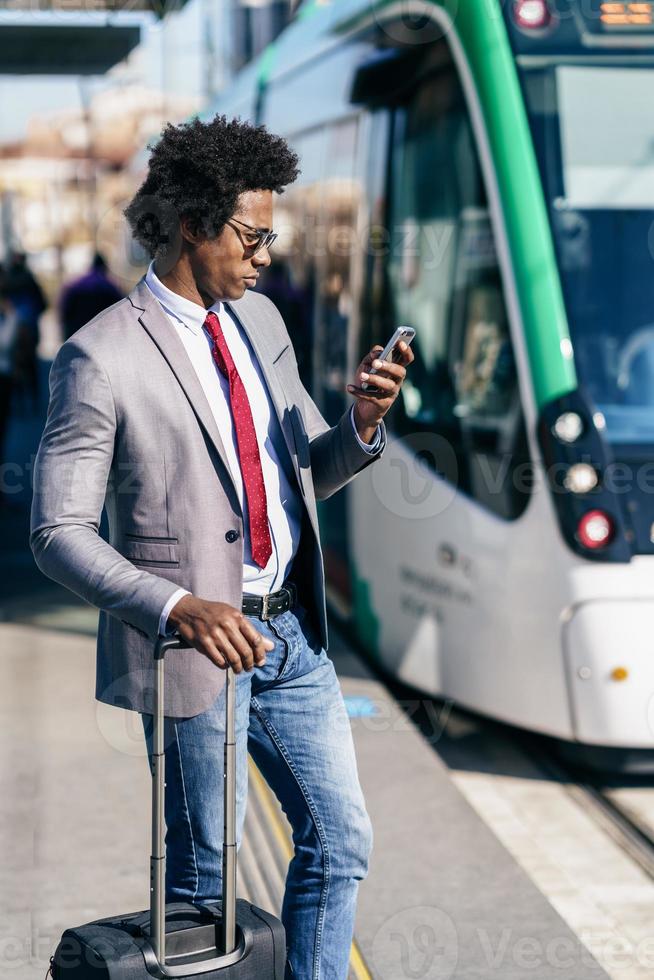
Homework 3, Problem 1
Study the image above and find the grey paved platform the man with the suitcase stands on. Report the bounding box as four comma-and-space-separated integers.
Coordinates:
0, 597, 608, 980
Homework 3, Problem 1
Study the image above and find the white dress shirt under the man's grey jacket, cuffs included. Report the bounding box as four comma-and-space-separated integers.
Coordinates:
145, 261, 381, 634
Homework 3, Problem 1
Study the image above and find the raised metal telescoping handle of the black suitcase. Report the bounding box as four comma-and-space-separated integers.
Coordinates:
150, 633, 236, 967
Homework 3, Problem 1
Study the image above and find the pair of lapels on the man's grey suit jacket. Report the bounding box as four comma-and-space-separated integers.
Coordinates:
129, 277, 299, 498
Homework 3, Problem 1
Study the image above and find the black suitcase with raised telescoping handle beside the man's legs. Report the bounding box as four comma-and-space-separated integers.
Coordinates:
50, 635, 286, 980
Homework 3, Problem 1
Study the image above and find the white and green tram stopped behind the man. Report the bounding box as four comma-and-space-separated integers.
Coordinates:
206, 0, 654, 768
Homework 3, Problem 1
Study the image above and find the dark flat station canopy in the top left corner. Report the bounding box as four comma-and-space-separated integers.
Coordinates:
0, 0, 190, 75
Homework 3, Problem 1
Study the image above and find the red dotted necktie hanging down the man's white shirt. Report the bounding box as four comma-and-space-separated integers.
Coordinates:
204, 312, 272, 568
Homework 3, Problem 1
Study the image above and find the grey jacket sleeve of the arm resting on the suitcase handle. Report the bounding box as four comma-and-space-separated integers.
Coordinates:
30, 337, 186, 639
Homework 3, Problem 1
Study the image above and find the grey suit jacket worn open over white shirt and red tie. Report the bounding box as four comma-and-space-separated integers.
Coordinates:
30, 279, 386, 716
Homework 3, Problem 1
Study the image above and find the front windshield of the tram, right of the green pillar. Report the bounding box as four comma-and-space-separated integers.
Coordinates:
523, 62, 654, 444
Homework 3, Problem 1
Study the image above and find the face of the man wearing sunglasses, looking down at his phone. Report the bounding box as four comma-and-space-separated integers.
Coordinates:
191, 190, 272, 306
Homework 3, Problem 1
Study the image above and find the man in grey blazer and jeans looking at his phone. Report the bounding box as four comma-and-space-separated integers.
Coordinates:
31, 116, 411, 980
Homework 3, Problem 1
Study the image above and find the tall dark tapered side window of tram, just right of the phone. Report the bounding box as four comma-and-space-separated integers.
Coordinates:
384, 53, 529, 519
